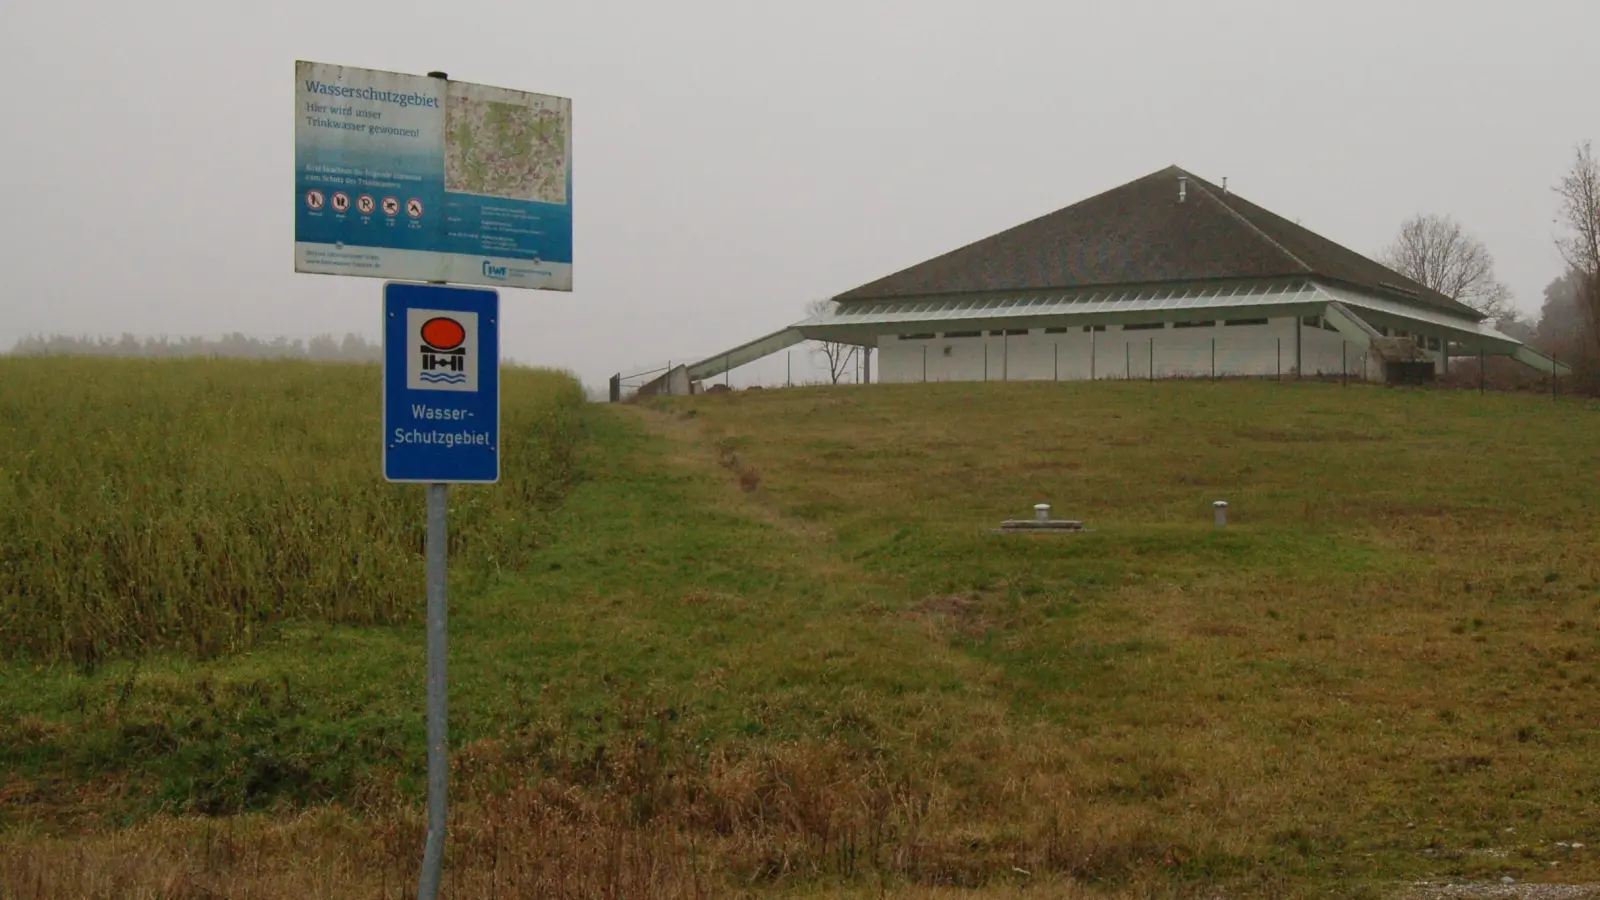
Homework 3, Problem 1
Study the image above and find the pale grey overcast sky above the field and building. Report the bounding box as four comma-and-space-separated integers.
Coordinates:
0, 0, 1600, 384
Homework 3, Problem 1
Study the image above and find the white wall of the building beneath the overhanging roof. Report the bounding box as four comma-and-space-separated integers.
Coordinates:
878, 319, 1337, 383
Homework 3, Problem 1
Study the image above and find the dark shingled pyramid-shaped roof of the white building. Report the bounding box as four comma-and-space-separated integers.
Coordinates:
834, 167, 1483, 320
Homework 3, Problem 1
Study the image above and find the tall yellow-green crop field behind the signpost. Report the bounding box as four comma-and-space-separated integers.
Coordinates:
0, 357, 582, 666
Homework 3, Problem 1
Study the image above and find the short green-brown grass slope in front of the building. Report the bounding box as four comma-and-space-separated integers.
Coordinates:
0, 364, 1600, 897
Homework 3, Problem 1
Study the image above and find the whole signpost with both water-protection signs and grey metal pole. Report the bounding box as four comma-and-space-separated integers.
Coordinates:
294, 59, 569, 900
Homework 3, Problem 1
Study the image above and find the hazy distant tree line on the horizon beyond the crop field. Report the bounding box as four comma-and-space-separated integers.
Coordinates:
11, 331, 382, 362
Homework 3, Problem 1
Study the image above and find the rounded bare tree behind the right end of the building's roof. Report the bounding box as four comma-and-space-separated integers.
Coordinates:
1379, 215, 1517, 320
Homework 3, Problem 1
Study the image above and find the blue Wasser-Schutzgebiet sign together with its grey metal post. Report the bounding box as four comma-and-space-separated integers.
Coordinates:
384, 282, 501, 900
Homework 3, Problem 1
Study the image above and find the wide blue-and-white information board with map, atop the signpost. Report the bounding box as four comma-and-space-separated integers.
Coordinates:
294, 61, 573, 291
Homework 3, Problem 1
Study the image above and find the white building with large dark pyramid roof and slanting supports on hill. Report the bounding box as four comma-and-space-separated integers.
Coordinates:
659, 167, 1565, 390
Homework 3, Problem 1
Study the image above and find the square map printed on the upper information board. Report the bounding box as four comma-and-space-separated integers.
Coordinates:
445, 85, 568, 203
